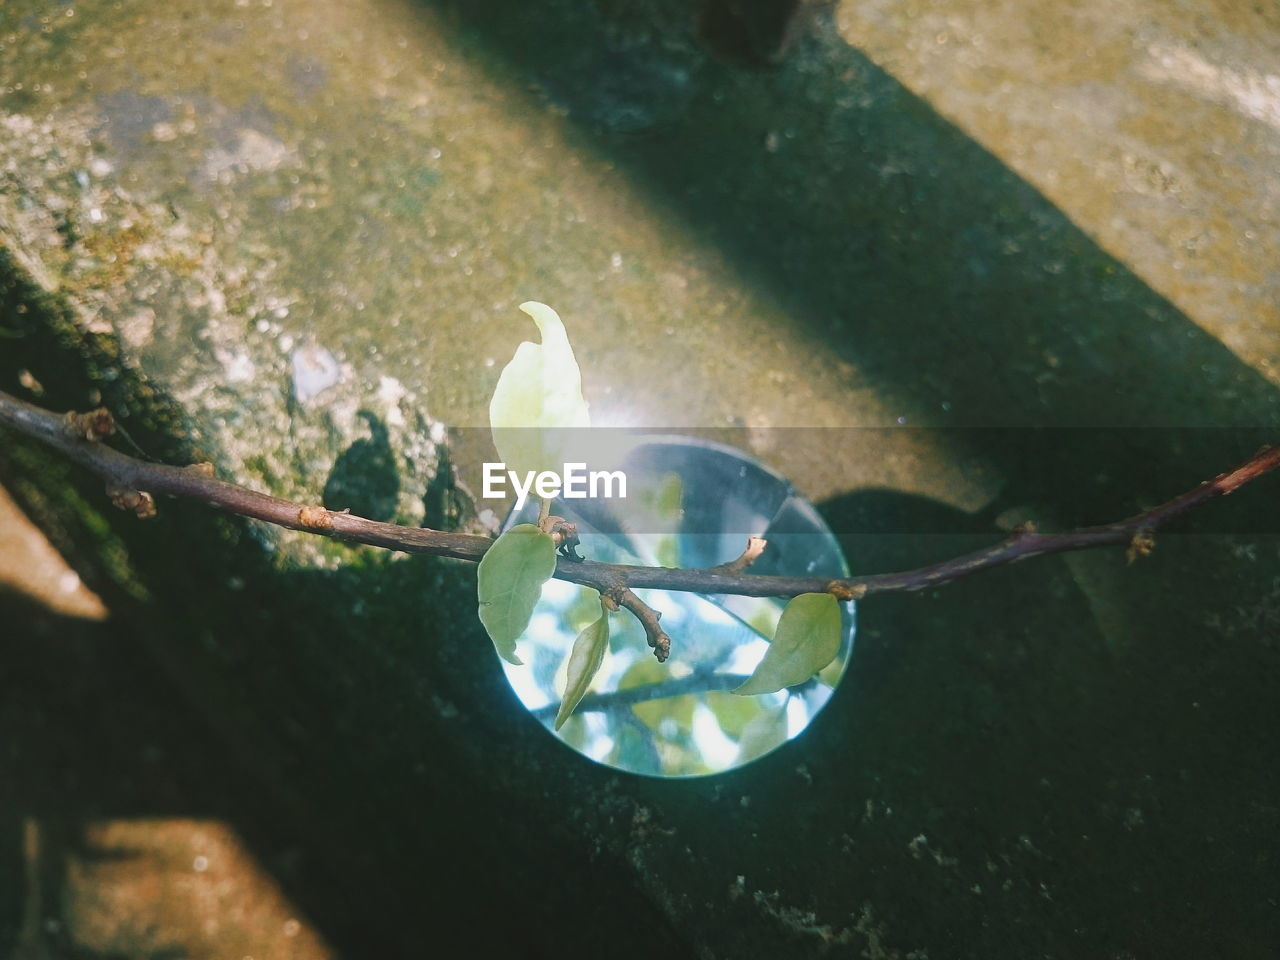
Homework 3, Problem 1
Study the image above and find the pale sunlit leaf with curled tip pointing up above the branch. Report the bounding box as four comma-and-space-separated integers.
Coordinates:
489, 301, 591, 475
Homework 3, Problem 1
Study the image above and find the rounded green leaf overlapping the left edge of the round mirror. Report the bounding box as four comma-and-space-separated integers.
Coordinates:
476, 524, 556, 666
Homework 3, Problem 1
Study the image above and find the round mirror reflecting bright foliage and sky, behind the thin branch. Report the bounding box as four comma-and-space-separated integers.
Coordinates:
503, 438, 854, 777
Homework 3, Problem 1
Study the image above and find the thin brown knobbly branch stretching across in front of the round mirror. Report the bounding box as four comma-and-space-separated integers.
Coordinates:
0, 393, 1280, 616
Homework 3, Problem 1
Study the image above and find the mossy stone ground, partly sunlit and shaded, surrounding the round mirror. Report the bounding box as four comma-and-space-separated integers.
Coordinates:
0, 0, 1280, 960
